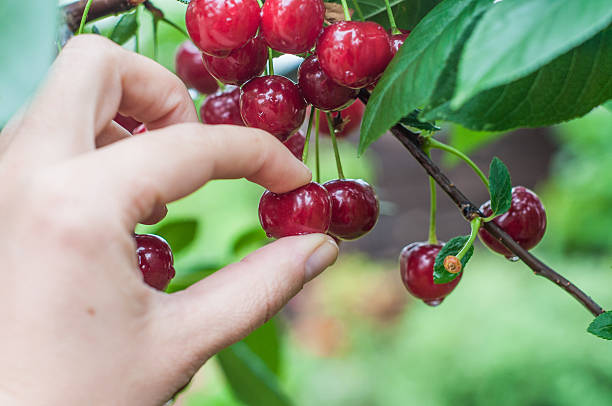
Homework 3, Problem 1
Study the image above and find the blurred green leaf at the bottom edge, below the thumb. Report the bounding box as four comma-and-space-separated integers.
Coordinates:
217, 342, 292, 406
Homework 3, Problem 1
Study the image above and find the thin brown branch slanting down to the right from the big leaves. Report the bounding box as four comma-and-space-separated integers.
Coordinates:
359, 89, 604, 316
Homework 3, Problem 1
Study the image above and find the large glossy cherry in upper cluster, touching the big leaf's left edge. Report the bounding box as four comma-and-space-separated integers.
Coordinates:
317, 21, 393, 89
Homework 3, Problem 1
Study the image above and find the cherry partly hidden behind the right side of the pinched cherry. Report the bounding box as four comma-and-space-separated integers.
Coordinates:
323, 179, 379, 240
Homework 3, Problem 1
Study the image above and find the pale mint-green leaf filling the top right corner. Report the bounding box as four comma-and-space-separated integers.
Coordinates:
451, 0, 612, 109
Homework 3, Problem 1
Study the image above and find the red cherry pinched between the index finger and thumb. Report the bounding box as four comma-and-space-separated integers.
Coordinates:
259, 182, 331, 238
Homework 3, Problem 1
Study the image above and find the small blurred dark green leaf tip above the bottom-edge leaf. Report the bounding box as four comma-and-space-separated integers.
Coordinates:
242, 317, 281, 376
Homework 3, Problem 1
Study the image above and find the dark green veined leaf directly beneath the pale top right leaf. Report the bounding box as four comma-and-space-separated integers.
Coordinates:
421, 27, 612, 131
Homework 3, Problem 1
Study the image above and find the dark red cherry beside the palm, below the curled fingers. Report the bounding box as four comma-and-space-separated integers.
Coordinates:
134, 234, 176, 290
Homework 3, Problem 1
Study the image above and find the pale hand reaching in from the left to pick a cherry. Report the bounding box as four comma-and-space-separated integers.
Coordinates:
0, 35, 338, 405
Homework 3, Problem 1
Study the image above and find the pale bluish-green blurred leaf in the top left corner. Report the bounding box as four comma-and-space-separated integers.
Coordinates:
0, 0, 57, 129
